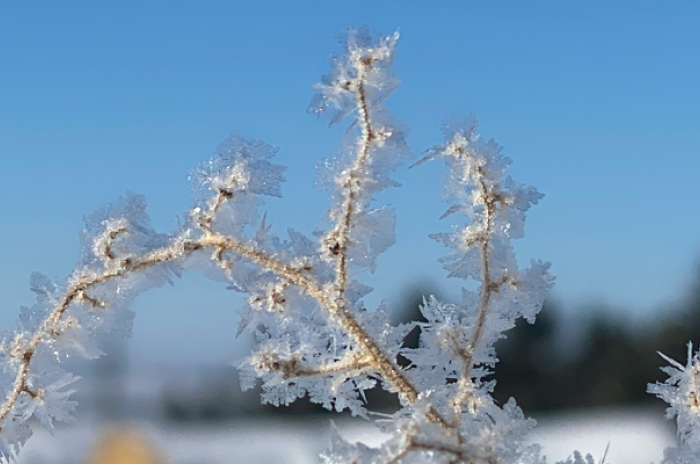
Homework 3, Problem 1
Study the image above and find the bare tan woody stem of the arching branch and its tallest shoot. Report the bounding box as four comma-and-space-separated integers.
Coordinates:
0, 29, 464, 455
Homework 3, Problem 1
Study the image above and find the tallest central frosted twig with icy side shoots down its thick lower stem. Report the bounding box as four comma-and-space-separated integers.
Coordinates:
241, 27, 426, 420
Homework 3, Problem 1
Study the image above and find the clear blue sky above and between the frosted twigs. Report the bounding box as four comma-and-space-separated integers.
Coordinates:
0, 1, 700, 366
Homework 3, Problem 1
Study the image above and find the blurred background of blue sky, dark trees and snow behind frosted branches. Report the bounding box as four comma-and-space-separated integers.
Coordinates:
0, 0, 700, 464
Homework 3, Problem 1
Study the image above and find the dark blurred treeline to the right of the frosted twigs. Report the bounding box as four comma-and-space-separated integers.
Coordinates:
494, 276, 700, 413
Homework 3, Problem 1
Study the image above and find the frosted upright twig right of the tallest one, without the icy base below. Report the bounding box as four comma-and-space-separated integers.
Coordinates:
405, 118, 554, 426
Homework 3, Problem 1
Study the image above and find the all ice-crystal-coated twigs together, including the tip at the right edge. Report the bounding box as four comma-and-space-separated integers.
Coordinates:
0, 24, 700, 464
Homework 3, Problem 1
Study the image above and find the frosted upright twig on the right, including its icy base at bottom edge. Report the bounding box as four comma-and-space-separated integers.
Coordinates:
325, 108, 554, 463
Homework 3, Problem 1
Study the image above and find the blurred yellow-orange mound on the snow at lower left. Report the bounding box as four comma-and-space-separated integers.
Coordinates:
85, 425, 165, 464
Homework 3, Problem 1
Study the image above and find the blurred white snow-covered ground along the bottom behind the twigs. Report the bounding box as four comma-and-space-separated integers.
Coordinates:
18, 410, 674, 464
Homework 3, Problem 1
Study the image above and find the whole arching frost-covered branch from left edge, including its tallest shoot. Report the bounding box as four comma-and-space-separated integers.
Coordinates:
0, 31, 454, 456
